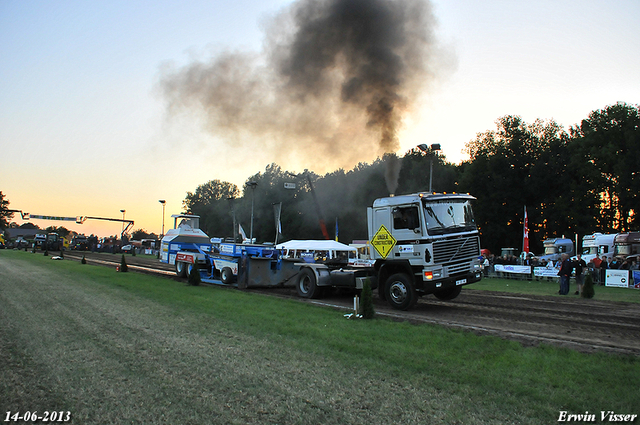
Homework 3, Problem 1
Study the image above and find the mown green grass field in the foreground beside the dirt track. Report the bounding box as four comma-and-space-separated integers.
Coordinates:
0, 251, 640, 424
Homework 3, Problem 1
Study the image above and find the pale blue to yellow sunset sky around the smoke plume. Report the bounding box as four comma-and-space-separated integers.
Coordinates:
0, 0, 640, 236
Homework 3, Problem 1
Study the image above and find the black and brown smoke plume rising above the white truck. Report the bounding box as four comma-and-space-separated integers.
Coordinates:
161, 0, 434, 193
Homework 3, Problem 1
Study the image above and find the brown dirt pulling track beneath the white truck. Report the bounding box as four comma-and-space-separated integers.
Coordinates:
65, 252, 640, 355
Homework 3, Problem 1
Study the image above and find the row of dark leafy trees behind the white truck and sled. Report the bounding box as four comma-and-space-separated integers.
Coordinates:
0, 103, 640, 253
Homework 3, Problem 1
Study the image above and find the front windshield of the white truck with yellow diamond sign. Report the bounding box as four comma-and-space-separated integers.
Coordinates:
424, 200, 476, 235
